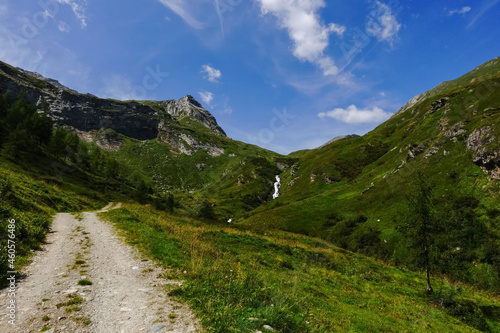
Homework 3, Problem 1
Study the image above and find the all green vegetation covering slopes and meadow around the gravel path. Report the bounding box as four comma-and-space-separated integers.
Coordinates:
0, 59, 500, 332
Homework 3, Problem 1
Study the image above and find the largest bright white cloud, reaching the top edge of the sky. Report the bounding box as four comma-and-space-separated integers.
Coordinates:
258, 0, 346, 75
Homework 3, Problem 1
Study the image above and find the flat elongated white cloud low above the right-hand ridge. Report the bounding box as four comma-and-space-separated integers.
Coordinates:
318, 105, 391, 124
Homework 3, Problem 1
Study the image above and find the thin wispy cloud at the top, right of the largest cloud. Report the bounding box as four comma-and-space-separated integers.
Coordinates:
366, 1, 401, 45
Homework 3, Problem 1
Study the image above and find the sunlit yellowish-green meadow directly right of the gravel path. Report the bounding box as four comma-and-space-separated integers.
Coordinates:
103, 201, 500, 332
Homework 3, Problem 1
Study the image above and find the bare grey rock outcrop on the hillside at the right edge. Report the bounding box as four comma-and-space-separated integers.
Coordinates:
465, 126, 500, 180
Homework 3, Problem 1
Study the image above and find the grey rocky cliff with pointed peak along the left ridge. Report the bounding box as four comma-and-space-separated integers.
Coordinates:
0, 62, 226, 153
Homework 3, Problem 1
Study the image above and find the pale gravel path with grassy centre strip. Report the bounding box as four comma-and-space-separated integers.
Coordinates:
0, 204, 200, 333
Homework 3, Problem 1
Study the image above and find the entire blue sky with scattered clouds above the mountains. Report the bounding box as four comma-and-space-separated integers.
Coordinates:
0, 0, 500, 153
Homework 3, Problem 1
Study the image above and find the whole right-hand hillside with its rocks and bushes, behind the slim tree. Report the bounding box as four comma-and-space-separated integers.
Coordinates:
240, 58, 500, 289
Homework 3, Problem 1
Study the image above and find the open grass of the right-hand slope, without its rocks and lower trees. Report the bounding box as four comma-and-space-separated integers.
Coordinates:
243, 59, 500, 246
